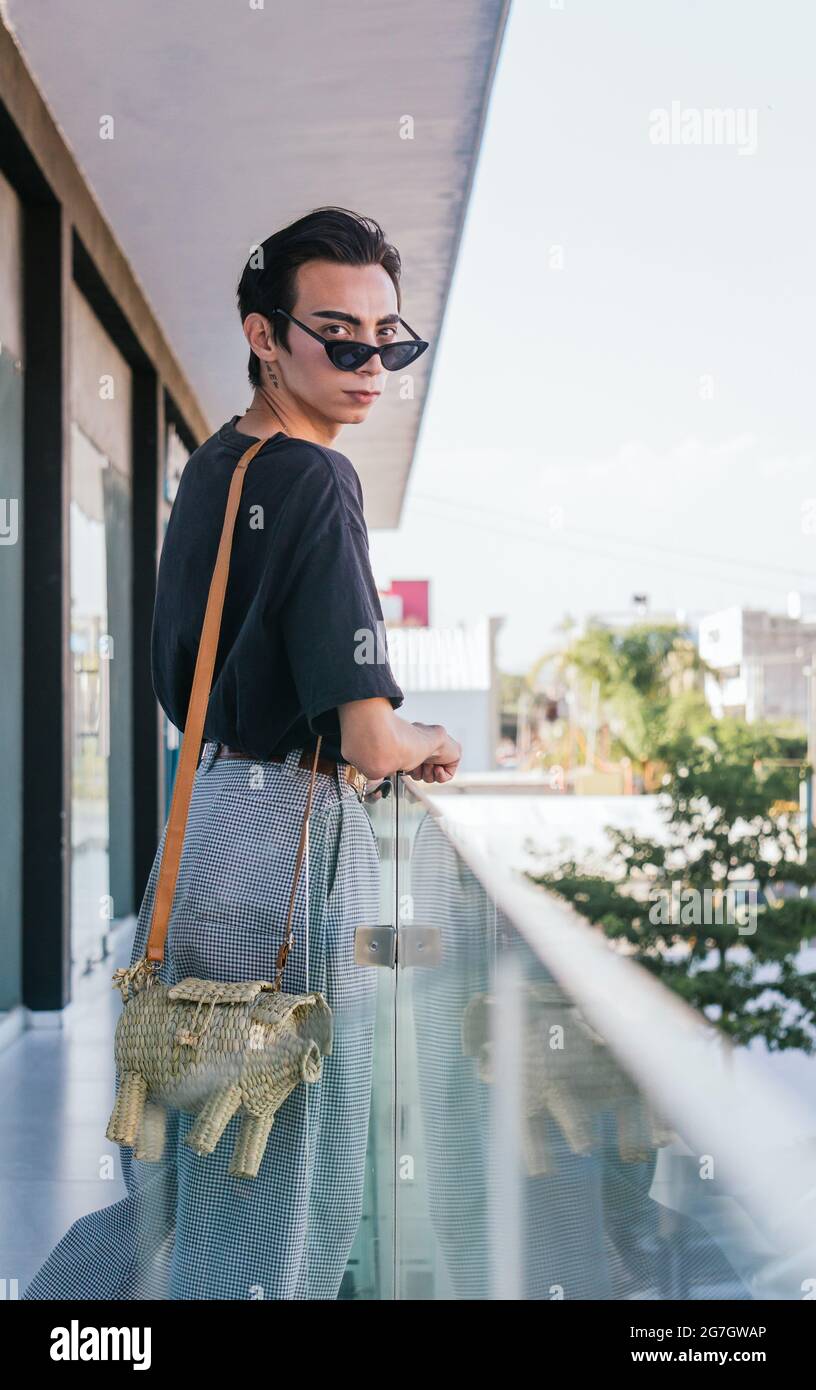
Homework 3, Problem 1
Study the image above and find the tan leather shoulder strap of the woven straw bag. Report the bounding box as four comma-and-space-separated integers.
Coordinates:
146, 439, 323, 988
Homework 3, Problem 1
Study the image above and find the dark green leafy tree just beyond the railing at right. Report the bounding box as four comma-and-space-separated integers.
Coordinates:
530, 719, 816, 1054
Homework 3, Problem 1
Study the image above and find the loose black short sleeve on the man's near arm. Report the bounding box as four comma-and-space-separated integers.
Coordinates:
279, 461, 405, 735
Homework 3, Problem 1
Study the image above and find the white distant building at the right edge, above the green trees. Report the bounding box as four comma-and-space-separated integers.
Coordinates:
699, 605, 816, 724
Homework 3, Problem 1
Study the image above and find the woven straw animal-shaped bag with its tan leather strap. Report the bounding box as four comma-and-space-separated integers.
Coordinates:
106, 439, 332, 1177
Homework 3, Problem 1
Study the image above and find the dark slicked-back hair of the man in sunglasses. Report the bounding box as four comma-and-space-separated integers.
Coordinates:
238, 207, 402, 386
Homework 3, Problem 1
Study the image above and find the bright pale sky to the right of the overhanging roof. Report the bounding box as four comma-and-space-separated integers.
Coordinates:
371, 0, 816, 671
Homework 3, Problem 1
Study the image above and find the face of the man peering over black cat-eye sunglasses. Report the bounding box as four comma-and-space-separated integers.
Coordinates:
261, 260, 397, 424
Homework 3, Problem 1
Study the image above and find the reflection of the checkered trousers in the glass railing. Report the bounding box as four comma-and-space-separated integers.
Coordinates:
409, 816, 610, 1300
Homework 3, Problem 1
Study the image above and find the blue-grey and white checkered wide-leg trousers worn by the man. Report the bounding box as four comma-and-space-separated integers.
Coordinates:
22, 744, 380, 1300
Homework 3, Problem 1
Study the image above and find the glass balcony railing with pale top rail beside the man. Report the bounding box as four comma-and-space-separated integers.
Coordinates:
364, 774, 816, 1300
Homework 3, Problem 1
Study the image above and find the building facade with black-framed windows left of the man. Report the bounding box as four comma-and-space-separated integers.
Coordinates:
0, 26, 210, 1040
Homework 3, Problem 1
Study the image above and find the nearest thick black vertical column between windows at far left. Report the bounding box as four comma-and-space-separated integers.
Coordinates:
22, 202, 71, 1009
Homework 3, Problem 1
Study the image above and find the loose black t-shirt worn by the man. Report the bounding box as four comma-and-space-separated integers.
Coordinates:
150, 416, 405, 759
